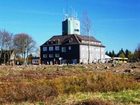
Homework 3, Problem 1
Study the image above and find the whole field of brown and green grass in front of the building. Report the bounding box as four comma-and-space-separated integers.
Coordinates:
0, 63, 140, 105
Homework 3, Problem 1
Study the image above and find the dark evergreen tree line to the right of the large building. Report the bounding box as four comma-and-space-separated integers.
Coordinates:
106, 43, 140, 62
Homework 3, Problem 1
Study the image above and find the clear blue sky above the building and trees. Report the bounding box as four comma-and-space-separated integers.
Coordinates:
0, 0, 140, 52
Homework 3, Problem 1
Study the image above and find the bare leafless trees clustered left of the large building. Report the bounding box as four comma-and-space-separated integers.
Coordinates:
0, 30, 36, 63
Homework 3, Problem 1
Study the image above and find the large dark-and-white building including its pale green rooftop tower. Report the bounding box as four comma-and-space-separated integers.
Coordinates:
40, 18, 105, 64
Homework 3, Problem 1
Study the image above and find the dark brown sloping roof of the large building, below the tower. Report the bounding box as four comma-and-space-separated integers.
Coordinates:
42, 34, 104, 47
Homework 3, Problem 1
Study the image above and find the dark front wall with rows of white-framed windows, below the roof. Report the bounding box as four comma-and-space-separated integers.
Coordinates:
40, 45, 79, 64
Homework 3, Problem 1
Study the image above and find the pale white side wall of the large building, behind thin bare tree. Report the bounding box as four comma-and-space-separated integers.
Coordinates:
80, 45, 105, 63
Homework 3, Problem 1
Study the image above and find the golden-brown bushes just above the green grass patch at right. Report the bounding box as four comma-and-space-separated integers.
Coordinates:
53, 72, 140, 94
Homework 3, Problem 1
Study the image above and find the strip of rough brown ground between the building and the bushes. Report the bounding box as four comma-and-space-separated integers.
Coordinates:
0, 62, 140, 82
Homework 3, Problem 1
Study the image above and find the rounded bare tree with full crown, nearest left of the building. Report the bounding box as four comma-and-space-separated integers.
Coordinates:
14, 33, 35, 63
